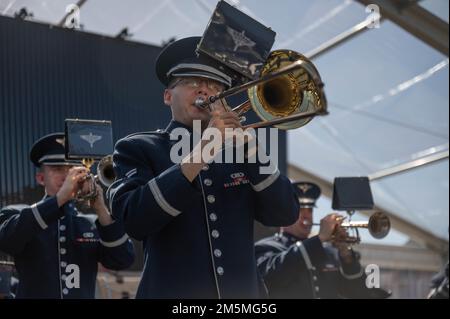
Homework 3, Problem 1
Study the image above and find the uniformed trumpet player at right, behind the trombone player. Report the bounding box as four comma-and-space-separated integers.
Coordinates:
255, 182, 388, 299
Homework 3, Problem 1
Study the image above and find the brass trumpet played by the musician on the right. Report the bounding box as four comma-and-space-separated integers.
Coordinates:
312, 212, 391, 244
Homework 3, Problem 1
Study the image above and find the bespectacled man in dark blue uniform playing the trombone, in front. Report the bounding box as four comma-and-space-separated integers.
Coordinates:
108, 37, 298, 299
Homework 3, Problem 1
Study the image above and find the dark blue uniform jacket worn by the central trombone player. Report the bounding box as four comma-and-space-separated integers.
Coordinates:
109, 121, 298, 298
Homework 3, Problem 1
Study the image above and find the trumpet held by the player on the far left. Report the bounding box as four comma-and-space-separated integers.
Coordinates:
76, 155, 116, 201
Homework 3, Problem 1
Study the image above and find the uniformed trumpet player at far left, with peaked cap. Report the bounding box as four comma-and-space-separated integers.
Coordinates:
0, 133, 134, 299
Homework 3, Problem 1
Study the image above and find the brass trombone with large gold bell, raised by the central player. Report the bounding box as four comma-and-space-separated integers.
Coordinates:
195, 50, 328, 130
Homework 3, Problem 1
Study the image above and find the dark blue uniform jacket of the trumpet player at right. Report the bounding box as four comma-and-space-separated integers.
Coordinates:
255, 233, 370, 299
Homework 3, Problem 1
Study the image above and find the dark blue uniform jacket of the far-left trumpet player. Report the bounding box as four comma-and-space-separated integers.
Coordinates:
0, 197, 134, 298
